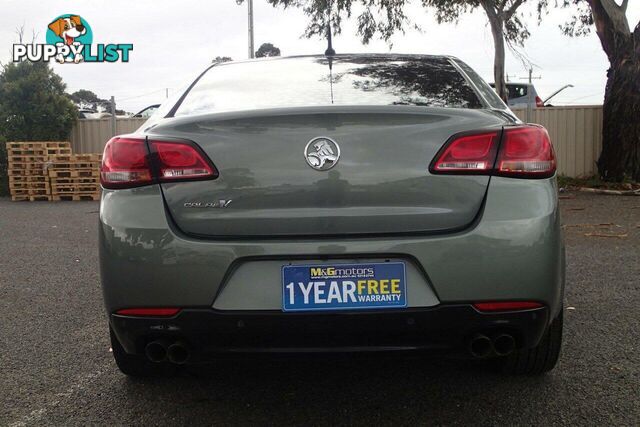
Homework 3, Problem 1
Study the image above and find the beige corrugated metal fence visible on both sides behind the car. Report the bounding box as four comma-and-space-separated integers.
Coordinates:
71, 105, 602, 177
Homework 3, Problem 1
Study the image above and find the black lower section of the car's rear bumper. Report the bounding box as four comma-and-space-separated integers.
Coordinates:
110, 304, 549, 363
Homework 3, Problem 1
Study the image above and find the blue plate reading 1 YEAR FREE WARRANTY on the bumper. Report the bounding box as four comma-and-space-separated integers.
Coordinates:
282, 262, 407, 311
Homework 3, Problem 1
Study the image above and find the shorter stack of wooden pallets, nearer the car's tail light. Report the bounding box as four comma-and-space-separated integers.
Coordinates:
47, 154, 102, 201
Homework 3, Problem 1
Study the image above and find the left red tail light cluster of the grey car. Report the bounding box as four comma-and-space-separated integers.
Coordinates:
100, 137, 218, 188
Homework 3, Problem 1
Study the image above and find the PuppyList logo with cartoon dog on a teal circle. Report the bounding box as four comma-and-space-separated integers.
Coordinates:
13, 14, 133, 64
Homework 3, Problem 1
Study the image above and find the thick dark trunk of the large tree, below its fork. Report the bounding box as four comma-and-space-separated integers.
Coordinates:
598, 54, 640, 181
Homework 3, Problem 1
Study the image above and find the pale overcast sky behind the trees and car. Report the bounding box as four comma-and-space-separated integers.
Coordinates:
0, 0, 640, 112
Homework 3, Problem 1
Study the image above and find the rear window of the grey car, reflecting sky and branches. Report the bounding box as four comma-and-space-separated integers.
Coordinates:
175, 55, 482, 116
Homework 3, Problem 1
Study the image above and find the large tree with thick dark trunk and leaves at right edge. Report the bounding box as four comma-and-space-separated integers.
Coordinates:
542, 0, 640, 181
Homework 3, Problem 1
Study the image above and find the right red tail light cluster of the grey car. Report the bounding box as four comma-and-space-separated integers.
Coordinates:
429, 125, 556, 178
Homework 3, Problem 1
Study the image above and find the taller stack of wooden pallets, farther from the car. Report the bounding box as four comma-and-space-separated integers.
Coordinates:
7, 142, 71, 202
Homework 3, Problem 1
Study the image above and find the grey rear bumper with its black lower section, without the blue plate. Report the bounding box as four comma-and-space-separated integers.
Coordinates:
99, 177, 565, 360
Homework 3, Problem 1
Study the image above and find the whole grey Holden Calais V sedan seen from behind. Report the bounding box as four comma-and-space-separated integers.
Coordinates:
99, 55, 565, 376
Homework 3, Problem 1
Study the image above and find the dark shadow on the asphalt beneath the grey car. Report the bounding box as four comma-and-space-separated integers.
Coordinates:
115, 354, 554, 425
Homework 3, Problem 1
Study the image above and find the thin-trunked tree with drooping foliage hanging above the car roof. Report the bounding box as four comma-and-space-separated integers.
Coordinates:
267, 0, 529, 99
